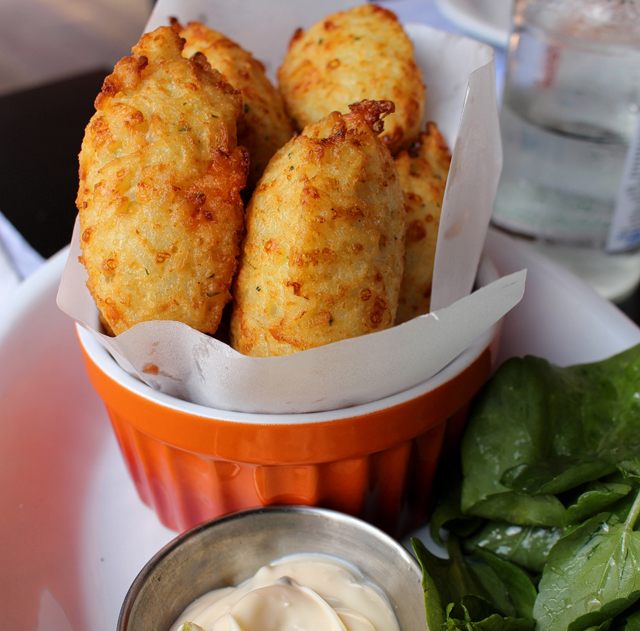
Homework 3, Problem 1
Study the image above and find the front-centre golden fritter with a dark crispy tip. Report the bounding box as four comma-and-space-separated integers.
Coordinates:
231, 101, 405, 357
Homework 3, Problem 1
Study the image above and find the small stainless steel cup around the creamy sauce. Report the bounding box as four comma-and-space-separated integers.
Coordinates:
118, 506, 427, 631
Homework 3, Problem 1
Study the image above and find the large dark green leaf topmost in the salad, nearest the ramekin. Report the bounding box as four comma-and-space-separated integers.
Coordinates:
461, 346, 640, 526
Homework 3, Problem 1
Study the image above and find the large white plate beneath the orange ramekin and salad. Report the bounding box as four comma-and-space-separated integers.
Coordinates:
0, 232, 640, 631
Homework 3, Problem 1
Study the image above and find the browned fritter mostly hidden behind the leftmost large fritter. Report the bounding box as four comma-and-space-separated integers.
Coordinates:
171, 19, 293, 191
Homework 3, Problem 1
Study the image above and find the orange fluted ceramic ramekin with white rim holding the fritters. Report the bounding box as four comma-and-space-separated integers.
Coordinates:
78, 314, 500, 537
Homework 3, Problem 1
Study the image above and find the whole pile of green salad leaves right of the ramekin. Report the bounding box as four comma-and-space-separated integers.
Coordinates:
413, 346, 640, 631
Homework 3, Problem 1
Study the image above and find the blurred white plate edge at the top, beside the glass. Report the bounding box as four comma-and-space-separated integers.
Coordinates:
436, 0, 512, 47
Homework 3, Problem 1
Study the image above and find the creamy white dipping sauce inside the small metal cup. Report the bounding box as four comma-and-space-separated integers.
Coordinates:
171, 554, 400, 631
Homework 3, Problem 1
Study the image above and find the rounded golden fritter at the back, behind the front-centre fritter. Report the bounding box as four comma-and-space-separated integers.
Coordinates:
278, 4, 425, 155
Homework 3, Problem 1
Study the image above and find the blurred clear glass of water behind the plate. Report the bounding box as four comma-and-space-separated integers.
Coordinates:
493, 0, 640, 299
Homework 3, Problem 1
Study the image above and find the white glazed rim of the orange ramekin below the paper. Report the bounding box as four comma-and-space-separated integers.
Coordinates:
76, 257, 500, 425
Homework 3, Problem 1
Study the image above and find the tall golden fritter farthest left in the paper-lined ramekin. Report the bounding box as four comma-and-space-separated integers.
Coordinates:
76, 27, 248, 335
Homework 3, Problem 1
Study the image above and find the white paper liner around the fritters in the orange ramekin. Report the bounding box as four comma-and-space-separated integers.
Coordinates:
58, 6, 525, 420
